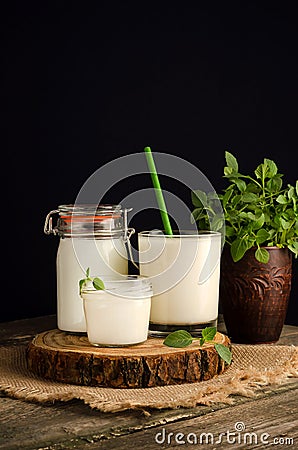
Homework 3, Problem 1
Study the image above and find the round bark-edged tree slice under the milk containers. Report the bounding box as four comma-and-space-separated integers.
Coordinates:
27, 330, 230, 388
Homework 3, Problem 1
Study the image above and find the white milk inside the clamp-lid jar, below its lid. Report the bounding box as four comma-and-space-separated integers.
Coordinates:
57, 238, 128, 332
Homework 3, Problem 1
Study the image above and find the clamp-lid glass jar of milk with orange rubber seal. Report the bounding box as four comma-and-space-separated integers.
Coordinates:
44, 204, 134, 332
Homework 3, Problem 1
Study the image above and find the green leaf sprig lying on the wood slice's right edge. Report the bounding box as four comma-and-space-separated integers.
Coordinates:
163, 327, 232, 364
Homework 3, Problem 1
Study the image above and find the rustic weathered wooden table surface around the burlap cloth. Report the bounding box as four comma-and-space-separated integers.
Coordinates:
0, 316, 298, 450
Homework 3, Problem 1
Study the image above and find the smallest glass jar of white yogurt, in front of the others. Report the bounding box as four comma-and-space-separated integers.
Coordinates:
81, 275, 152, 347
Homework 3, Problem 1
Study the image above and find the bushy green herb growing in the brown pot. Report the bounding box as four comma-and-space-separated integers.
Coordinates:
192, 152, 298, 263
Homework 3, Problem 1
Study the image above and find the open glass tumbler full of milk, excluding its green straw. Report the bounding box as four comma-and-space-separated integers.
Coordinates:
138, 231, 221, 337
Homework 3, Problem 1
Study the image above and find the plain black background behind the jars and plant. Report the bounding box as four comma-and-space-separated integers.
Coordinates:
1, 1, 298, 325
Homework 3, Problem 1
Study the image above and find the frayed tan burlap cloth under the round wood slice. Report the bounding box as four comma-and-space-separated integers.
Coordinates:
0, 345, 298, 412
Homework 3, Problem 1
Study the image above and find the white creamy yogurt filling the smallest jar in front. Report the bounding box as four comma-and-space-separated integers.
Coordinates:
82, 291, 151, 346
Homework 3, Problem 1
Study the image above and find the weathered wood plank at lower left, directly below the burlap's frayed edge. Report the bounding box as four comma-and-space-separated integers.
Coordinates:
0, 379, 298, 450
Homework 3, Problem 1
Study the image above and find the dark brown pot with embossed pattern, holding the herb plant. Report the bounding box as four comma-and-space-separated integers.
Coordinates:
220, 247, 292, 344
